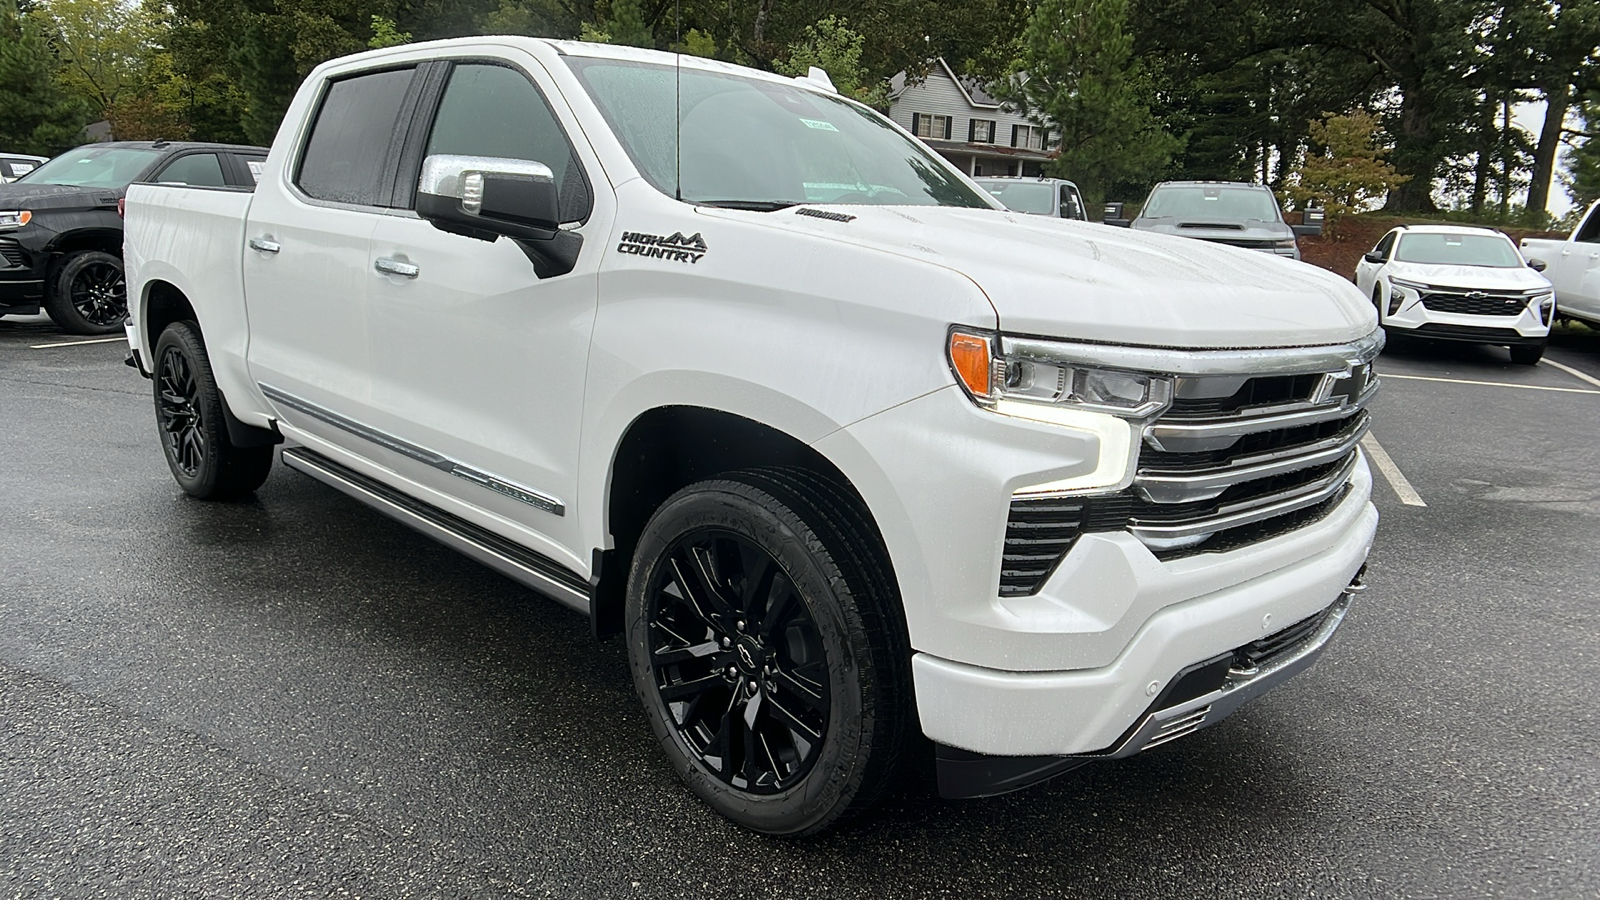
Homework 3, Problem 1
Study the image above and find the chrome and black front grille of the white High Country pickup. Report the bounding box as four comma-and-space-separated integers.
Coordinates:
1000, 350, 1378, 596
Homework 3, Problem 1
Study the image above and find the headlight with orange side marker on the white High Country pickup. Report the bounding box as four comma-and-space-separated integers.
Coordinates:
949, 330, 1173, 420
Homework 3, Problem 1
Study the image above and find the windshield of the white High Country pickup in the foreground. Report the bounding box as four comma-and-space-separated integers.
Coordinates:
566, 56, 989, 208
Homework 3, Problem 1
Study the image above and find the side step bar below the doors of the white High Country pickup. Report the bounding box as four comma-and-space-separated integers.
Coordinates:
283, 447, 590, 615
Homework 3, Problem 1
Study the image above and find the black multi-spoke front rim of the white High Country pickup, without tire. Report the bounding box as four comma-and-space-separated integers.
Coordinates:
648, 528, 829, 794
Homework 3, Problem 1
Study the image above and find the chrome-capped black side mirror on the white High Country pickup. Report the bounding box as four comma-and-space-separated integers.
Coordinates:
416, 155, 562, 240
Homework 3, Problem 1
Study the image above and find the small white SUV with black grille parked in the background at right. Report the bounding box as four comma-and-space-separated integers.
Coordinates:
1355, 226, 1555, 365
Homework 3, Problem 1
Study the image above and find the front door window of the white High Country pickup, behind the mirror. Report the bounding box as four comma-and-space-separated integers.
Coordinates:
426, 62, 590, 223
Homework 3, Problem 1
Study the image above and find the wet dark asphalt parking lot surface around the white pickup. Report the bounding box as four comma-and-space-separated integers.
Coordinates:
0, 312, 1600, 898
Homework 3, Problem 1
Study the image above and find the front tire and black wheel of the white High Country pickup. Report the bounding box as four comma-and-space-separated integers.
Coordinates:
626, 469, 914, 836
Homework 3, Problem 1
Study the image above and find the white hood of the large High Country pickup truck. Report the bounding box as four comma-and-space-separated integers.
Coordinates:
716, 207, 1378, 348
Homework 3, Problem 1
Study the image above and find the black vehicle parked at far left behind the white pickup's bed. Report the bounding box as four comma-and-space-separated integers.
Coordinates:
0, 141, 267, 335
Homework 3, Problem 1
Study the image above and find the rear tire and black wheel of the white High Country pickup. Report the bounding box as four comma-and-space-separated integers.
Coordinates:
152, 320, 272, 500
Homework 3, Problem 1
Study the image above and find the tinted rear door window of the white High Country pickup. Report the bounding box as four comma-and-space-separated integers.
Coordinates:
294, 69, 413, 207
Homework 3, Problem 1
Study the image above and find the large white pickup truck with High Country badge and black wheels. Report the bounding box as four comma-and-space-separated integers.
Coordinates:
126, 37, 1381, 834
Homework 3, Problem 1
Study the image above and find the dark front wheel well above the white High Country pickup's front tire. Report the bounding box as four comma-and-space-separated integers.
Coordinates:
590, 407, 898, 637
